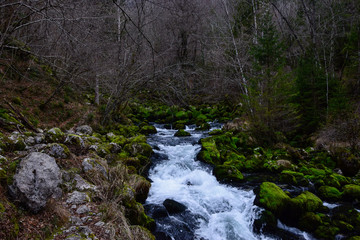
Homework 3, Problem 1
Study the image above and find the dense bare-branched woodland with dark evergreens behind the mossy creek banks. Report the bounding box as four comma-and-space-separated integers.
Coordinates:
0, 0, 360, 141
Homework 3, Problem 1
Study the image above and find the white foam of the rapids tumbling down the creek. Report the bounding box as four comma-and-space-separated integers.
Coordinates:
146, 125, 311, 240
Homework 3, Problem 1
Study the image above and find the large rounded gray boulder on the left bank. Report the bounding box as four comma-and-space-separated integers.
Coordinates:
9, 152, 62, 213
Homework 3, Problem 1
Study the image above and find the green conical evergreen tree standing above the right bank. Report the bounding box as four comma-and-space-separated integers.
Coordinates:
251, 13, 297, 144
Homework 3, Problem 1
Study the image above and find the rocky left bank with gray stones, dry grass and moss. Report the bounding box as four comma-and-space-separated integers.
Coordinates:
0, 125, 156, 240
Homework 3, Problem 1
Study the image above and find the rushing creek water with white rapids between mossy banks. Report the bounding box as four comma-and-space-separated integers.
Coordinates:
144, 124, 311, 240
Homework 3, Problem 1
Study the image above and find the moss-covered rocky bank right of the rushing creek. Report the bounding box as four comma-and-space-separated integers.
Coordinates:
197, 120, 360, 240
